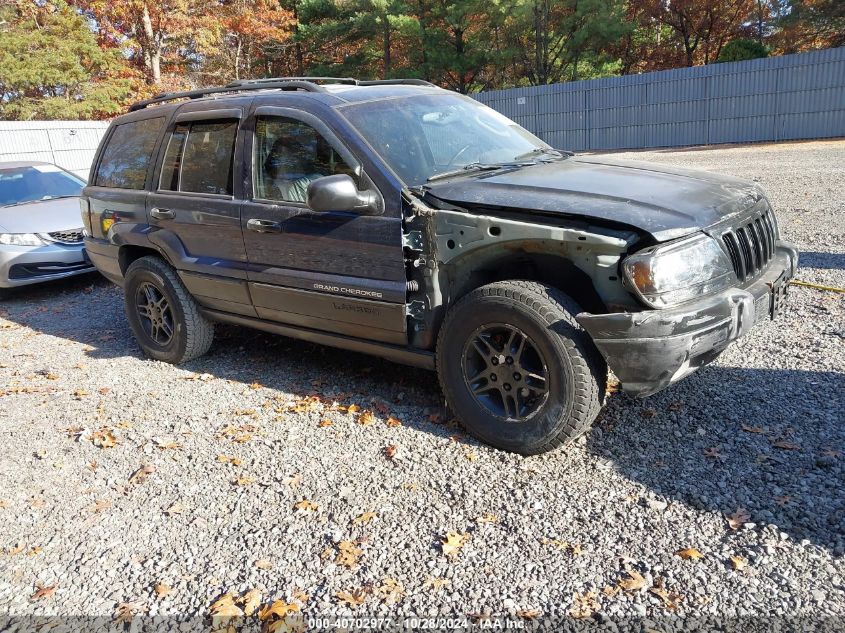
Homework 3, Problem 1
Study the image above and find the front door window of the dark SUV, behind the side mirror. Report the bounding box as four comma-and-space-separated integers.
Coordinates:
253, 116, 354, 203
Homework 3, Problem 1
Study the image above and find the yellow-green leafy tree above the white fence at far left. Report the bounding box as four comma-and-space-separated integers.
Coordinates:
0, 0, 139, 119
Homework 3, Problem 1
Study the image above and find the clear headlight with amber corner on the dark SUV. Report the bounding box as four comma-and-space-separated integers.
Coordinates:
622, 233, 736, 308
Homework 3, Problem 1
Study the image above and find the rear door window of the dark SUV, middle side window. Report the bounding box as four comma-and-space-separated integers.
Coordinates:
159, 120, 238, 195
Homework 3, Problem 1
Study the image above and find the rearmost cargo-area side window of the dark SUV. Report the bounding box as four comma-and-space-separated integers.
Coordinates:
94, 117, 164, 189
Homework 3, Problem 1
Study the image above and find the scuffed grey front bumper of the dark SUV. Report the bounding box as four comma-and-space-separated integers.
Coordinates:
576, 241, 798, 397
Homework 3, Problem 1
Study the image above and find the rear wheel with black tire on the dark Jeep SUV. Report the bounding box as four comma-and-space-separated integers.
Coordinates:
123, 256, 214, 364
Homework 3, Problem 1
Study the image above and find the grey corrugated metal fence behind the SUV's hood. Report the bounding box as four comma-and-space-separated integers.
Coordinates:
473, 48, 845, 150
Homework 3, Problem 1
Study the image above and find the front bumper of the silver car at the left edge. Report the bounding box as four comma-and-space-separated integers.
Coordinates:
0, 244, 96, 288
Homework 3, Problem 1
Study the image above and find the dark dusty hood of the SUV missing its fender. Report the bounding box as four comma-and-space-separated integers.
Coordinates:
427, 156, 763, 241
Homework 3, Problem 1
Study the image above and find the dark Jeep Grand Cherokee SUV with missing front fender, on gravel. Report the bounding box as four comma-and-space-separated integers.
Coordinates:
83, 78, 798, 454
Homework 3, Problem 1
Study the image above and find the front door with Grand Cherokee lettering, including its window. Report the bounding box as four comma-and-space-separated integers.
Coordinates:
241, 106, 407, 345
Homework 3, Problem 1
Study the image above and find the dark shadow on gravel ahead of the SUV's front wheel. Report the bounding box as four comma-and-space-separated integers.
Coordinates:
587, 366, 845, 556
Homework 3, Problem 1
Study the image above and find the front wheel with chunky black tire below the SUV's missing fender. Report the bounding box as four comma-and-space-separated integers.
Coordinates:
437, 281, 607, 455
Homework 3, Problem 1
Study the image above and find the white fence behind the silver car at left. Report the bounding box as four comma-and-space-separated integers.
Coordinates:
0, 121, 109, 180
